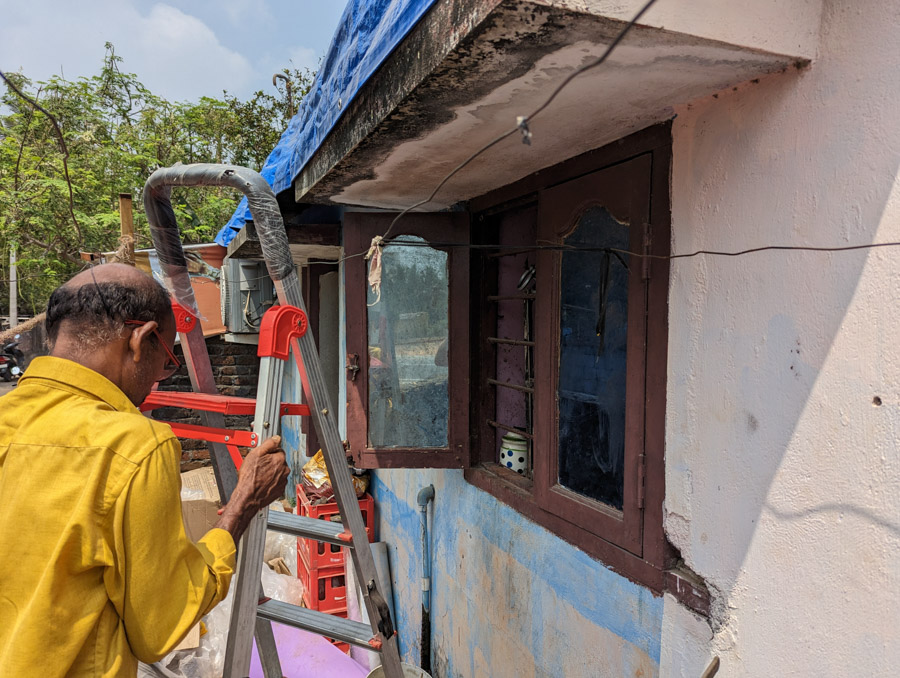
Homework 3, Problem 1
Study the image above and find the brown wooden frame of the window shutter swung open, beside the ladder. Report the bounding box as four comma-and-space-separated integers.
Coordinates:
344, 212, 469, 468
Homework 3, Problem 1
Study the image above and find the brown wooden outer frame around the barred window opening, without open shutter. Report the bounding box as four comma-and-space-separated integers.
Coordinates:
465, 124, 672, 596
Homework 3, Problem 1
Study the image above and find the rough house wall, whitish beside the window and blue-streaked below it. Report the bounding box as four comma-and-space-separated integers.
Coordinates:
340, 0, 900, 678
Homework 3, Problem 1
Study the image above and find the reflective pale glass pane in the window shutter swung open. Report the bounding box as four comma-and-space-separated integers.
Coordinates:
367, 236, 449, 448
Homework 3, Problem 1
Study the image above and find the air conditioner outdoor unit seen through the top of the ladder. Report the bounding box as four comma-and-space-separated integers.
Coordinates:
220, 258, 275, 334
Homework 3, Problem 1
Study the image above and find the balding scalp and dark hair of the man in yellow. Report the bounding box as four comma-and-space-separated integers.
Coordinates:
45, 264, 172, 349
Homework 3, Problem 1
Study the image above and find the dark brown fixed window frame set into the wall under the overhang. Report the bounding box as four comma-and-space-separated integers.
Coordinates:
465, 124, 672, 596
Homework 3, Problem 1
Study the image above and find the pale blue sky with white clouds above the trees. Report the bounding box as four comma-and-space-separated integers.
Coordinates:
0, 0, 346, 100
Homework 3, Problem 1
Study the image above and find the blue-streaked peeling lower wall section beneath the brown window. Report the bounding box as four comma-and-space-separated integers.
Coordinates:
372, 470, 663, 678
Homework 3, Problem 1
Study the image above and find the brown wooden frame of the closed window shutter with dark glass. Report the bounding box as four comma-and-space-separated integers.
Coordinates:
534, 153, 652, 556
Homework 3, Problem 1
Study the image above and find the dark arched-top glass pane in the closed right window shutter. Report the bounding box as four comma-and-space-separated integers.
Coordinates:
557, 208, 629, 509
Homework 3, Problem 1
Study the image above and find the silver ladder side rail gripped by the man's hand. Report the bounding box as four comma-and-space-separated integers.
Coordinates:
223, 357, 284, 678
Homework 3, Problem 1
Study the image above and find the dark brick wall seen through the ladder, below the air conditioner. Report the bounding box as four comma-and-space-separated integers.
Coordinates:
153, 337, 259, 471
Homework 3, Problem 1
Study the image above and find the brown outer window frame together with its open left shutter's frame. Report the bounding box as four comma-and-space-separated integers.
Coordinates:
344, 123, 710, 614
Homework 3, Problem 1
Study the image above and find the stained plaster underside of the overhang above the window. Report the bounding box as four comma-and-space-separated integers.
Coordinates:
322, 2, 796, 211
